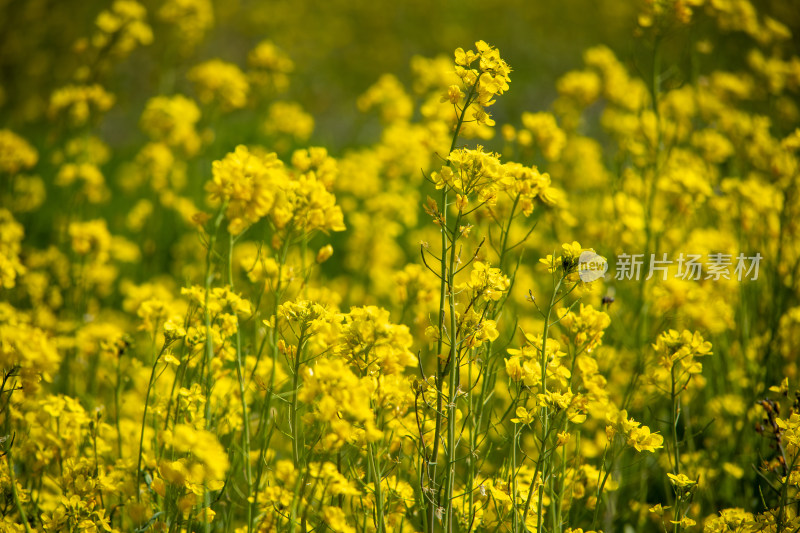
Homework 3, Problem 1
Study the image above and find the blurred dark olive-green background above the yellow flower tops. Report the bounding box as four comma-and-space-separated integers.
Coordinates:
6, 0, 800, 149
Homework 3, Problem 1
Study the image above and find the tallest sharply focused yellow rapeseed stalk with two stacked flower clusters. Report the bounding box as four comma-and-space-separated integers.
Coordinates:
422, 41, 511, 532
